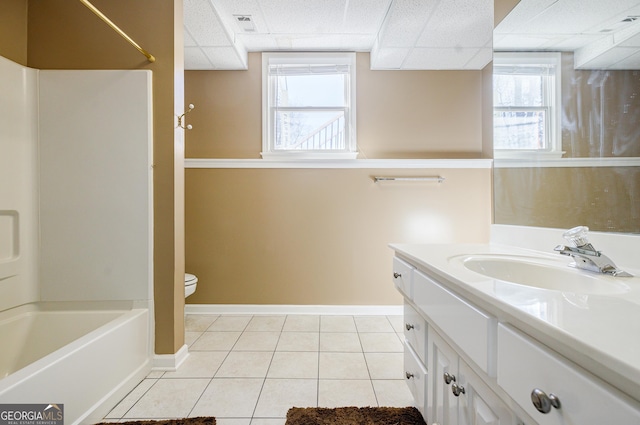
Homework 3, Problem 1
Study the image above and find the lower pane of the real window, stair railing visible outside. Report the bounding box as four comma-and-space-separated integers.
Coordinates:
274, 110, 346, 150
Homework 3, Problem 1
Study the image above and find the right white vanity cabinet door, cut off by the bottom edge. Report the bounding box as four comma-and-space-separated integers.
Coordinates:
457, 359, 517, 425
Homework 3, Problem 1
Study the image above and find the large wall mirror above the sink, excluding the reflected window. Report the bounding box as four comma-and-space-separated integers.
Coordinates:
494, 0, 640, 234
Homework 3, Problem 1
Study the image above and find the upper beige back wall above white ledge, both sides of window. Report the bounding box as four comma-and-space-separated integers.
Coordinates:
185, 53, 484, 158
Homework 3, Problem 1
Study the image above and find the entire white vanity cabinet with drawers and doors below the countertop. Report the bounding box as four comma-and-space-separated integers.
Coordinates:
394, 247, 640, 425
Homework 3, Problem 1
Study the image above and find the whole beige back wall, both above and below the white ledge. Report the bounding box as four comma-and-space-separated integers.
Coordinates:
185, 53, 492, 305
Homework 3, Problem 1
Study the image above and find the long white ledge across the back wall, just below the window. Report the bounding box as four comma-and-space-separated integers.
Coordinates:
184, 158, 493, 169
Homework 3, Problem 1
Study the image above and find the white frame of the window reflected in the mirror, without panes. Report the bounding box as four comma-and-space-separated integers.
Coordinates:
493, 52, 564, 159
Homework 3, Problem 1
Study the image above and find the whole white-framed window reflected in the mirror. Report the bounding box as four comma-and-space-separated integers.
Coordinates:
493, 53, 562, 158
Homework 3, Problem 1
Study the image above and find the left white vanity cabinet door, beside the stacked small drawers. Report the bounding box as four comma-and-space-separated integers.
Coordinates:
427, 327, 458, 425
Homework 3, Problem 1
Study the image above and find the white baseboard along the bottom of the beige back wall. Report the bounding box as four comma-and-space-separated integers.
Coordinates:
184, 304, 403, 316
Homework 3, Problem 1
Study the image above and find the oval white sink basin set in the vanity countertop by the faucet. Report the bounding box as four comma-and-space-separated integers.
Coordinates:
461, 255, 629, 295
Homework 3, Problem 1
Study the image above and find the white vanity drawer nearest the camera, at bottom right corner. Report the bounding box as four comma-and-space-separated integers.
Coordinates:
498, 324, 640, 425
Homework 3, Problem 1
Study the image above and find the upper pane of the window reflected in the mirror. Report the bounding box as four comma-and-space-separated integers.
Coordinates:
493, 74, 544, 107
